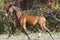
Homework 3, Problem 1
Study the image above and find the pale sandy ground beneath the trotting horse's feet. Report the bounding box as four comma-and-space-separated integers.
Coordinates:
0, 33, 60, 40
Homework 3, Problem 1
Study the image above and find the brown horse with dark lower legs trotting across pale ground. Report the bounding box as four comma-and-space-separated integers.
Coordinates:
4, 6, 53, 40
